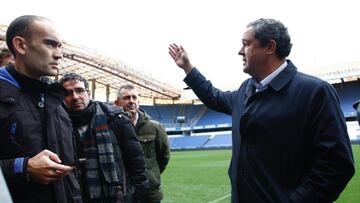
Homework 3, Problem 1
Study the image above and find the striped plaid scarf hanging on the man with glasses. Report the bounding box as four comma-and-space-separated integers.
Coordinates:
83, 102, 119, 199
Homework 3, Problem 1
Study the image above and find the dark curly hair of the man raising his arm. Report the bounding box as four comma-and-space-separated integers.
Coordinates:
247, 18, 292, 58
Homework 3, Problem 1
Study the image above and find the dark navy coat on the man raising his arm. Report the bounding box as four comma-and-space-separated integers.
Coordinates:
184, 61, 355, 203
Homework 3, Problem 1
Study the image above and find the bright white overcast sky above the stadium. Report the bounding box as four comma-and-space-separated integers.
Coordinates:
0, 0, 360, 89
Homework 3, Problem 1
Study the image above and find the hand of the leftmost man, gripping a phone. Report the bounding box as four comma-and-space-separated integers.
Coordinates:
27, 150, 73, 184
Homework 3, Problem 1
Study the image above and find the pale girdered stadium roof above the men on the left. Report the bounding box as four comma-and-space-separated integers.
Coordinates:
0, 24, 181, 101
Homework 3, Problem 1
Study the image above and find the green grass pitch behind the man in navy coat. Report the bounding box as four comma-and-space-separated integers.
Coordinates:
162, 145, 360, 203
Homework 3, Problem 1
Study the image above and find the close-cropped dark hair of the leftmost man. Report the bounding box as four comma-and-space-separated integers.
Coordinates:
6, 15, 49, 57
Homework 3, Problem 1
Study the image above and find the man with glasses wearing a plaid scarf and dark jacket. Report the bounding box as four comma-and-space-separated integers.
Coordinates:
60, 73, 148, 203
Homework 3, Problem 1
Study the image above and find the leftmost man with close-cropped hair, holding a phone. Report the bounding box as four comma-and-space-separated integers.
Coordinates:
0, 16, 82, 203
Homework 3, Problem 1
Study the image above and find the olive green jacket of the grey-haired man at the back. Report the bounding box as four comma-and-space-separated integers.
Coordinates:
135, 110, 170, 202
